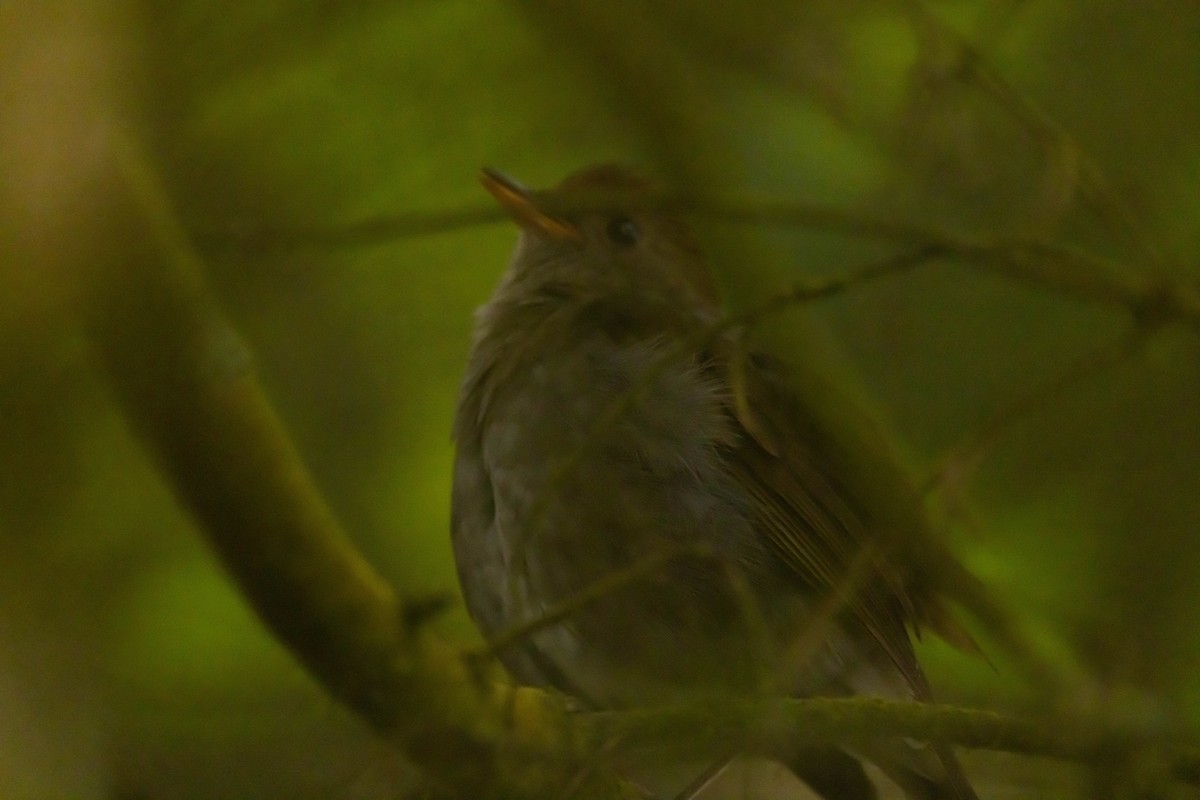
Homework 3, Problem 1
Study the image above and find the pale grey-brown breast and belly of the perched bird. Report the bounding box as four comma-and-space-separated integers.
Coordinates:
456, 311, 806, 696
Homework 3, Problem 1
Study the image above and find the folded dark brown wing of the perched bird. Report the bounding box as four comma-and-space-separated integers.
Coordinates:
716, 347, 930, 699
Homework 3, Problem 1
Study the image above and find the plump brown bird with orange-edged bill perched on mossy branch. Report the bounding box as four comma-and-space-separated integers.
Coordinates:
451, 166, 974, 800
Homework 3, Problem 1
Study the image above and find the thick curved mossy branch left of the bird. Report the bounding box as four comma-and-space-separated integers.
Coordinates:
77, 125, 641, 798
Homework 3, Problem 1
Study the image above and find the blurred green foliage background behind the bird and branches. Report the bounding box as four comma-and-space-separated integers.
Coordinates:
0, 0, 1200, 799
